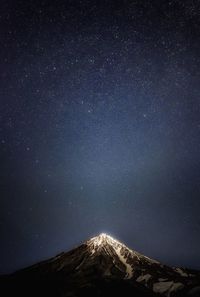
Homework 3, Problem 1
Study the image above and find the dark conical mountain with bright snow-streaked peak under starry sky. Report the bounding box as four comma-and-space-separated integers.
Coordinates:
0, 234, 200, 297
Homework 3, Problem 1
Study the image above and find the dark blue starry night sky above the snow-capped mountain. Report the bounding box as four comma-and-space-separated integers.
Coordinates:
0, 0, 200, 273
